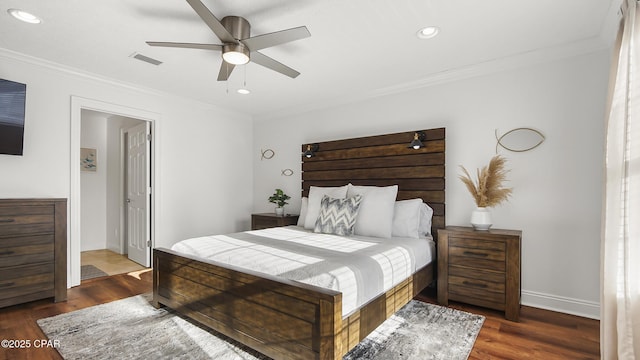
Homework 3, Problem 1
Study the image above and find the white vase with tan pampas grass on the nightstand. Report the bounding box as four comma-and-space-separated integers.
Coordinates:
459, 155, 513, 230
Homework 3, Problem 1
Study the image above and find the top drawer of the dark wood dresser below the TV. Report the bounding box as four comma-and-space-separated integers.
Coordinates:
0, 206, 54, 236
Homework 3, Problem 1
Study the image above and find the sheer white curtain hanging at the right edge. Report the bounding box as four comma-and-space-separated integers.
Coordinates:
600, 0, 640, 360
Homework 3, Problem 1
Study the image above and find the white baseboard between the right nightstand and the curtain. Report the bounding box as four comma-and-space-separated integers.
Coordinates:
520, 290, 600, 320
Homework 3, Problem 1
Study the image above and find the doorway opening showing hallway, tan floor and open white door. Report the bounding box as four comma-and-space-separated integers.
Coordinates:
80, 109, 151, 280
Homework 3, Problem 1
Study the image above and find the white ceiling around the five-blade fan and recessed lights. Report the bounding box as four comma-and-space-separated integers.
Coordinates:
0, 0, 620, 117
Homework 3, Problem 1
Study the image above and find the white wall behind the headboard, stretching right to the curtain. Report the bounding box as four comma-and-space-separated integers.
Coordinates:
253, 51, 610, 318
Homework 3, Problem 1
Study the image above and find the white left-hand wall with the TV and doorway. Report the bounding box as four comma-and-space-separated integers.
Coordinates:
0, 49, 253, 284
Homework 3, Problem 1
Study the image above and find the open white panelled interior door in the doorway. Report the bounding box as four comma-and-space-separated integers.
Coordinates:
127, 121, 151, 267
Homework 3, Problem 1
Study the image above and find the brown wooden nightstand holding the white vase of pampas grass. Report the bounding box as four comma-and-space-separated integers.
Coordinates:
438, 226, 522, 321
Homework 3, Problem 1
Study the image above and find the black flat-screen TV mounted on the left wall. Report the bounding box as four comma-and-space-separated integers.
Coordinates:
0, 79, 27, 155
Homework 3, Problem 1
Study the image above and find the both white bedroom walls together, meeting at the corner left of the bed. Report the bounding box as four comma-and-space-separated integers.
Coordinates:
0, 43, 609, 317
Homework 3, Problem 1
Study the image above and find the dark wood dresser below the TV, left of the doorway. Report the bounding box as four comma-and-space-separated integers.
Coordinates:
0, 199, 67, 307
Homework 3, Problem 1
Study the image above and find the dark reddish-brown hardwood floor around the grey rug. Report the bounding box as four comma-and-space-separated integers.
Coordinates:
0, 270, 600, 360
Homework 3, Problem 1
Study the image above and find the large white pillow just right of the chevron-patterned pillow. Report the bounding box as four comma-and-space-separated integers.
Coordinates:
347, 184, 398, 238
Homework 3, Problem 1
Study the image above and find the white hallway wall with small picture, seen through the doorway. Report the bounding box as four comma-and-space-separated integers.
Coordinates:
78, 110, 107, 251
